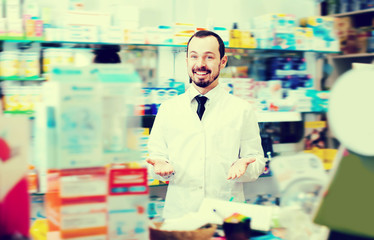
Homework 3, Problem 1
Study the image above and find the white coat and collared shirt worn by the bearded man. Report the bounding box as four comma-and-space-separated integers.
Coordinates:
148, 84, 265, 219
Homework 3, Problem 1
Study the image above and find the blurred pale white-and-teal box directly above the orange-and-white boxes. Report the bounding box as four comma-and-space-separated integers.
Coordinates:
43, 82, 105, 168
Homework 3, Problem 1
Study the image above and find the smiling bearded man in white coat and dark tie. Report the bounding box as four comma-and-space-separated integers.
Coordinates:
147, 31, 265, 219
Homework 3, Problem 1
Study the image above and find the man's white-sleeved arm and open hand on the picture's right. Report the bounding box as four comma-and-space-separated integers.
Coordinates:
228, 105, 265, 182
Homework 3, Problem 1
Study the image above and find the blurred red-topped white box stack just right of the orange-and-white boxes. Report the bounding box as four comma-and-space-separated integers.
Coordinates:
108, 168, 149, 240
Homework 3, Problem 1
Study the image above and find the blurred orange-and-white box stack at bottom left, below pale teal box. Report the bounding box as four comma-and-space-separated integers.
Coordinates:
45, 167, 108, 240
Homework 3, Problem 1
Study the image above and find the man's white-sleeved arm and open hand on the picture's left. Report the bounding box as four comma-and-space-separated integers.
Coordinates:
146, 105, 174, 181
